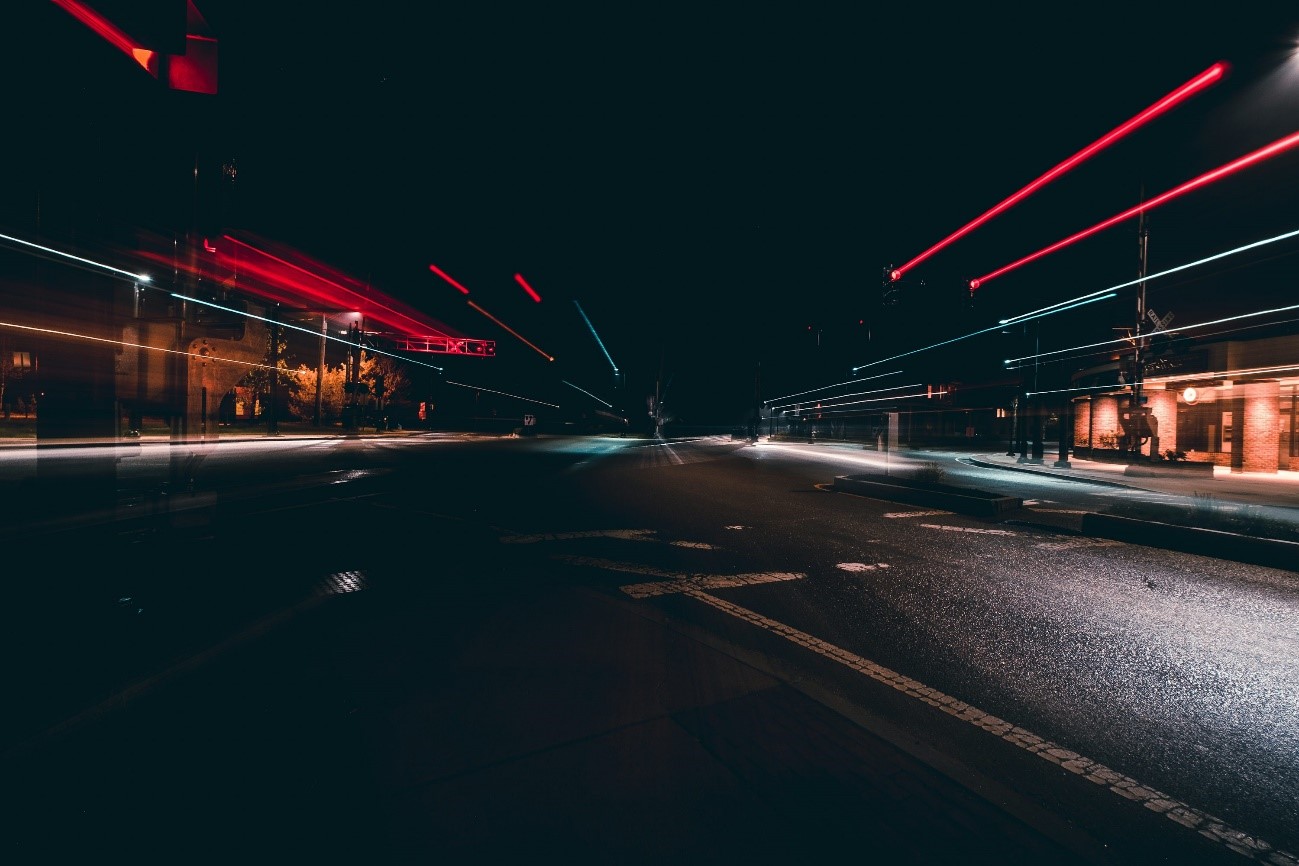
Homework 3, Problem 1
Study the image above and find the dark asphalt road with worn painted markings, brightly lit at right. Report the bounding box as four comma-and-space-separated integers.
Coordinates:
5, 436, 1299, 862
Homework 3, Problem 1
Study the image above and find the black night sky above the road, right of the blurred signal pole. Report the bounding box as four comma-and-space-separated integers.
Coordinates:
12, 0, 1299, 422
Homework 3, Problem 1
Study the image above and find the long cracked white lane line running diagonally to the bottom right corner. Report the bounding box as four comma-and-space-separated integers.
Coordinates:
622, 583, 1299, 866
